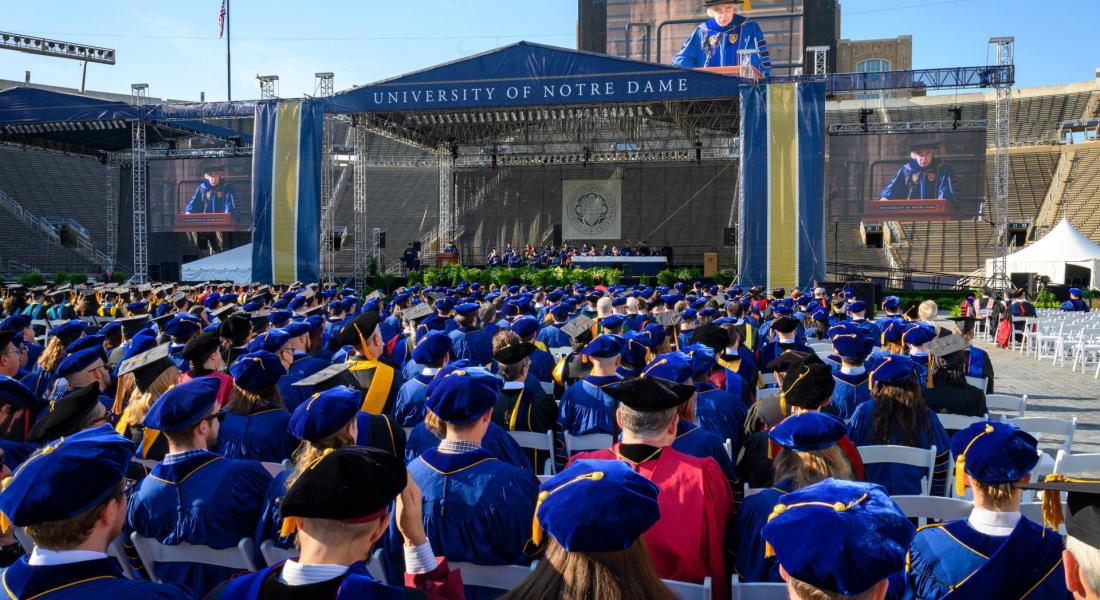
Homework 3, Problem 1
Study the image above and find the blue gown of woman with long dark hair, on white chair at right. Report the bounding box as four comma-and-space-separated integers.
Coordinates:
848, 400, 952, 495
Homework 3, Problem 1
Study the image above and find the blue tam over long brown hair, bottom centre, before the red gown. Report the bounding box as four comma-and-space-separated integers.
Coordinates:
532, 460, 661, 553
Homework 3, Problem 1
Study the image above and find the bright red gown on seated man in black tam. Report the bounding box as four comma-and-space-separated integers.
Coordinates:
571, 444, 734, 600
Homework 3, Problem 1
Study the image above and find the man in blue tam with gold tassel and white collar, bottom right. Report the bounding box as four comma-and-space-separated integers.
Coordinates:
905, 422, 1067, 600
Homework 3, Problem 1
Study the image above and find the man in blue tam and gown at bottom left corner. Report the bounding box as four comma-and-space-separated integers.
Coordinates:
0, 427, 187, 600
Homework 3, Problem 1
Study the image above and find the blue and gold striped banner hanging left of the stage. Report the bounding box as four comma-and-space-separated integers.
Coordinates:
252, 100, 325, 284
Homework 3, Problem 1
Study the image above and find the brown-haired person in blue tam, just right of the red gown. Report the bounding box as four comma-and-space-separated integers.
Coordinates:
732, 412, 853, 582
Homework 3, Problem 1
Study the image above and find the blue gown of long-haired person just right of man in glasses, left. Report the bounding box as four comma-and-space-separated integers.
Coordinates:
218, 406, 298, 462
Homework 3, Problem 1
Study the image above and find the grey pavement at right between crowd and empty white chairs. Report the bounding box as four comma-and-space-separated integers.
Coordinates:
976, 341, 1100, 454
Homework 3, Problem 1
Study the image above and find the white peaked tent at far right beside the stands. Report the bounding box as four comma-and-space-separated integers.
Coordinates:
986, 218, 1100, 288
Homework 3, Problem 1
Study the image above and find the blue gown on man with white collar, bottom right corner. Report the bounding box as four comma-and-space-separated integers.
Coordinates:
905, 519, 1070, 600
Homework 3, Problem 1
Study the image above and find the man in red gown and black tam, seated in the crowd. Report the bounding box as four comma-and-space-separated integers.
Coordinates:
573, 378, 733, 598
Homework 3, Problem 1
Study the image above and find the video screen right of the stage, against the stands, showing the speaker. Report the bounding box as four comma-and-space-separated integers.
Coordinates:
828, 131, 986, 221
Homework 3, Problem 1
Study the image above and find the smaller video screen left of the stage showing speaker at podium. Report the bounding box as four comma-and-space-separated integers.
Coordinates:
149, 156, 252, 232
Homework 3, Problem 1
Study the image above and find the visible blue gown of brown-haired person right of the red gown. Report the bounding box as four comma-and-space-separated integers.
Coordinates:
730, 479, 794, 583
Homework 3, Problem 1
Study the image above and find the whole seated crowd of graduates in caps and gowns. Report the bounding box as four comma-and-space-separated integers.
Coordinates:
0, 278, 1100, 600
